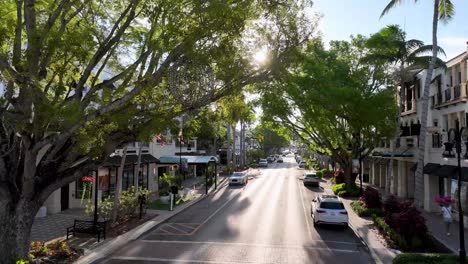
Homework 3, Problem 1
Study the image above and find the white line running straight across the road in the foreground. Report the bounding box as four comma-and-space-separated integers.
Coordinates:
139, 240, 360, 249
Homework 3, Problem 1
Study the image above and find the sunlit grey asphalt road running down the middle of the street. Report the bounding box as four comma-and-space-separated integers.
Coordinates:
101, 157, 372, 264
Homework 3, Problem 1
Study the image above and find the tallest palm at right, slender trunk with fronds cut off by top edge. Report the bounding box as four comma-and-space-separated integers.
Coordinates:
380, 0, 454, 206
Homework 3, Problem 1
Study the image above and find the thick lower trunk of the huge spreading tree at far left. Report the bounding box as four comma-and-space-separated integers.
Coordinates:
0, 195, 42, 263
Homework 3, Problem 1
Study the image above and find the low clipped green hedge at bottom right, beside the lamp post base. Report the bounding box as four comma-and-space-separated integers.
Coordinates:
392, 253, 468, 264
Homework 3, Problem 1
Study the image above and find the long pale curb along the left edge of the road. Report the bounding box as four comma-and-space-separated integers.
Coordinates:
74, 177, 227, 264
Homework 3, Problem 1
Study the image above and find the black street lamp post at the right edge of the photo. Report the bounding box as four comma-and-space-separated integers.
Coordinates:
444, 120, 468, 264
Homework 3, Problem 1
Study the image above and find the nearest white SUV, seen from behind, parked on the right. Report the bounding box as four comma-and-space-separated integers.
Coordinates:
310, 195, 348, 226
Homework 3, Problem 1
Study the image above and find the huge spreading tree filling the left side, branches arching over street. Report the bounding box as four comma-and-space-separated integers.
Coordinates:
0, 0, 316, 262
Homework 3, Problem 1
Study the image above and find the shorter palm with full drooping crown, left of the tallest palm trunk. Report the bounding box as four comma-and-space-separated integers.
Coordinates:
365, 25, 445, 192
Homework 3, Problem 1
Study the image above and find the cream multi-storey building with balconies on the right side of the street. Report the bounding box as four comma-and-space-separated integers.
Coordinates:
364, 43, 468, 227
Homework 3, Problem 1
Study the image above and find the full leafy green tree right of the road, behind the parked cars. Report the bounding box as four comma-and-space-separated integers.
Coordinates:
261, 36, 396, 188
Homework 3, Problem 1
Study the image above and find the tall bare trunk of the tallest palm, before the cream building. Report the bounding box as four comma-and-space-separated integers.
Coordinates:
414, 0, 439, 207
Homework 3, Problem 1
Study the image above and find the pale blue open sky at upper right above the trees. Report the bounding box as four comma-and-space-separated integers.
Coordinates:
313, 0, 468, 60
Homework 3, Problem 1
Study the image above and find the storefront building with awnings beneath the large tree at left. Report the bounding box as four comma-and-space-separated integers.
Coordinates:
38, 133, 217, 216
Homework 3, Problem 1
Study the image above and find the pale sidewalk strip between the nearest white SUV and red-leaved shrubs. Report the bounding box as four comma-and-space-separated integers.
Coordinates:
324, 179, 398, 264
